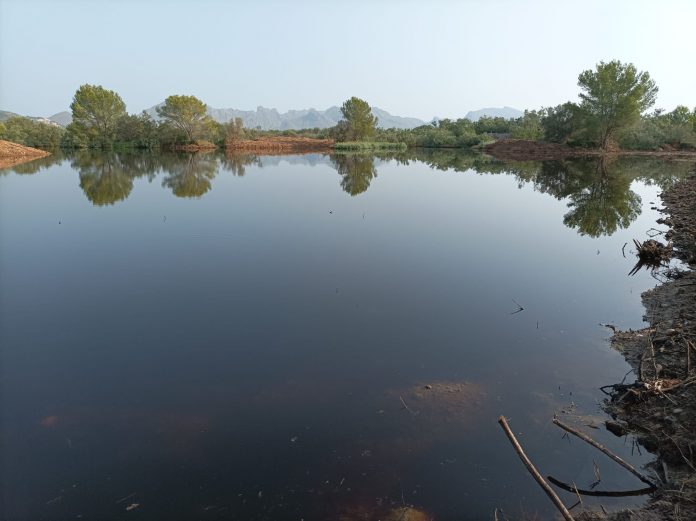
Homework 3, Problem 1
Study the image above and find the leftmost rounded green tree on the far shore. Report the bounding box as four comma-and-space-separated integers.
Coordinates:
69, 84, 126, 146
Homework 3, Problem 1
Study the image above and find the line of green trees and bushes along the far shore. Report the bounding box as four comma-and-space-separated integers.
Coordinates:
0, 61, 696, 150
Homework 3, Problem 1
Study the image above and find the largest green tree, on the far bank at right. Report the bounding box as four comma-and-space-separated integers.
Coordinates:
578, 60, 658, 149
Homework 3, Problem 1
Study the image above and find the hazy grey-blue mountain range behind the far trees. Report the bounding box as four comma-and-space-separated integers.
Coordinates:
0, 103, 523, 130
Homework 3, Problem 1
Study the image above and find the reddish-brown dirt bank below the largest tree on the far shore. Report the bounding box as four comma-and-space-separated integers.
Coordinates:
483, 139, 696, 161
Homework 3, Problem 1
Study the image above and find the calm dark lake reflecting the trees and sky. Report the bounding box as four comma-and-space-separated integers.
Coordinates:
0, 151, 693, 521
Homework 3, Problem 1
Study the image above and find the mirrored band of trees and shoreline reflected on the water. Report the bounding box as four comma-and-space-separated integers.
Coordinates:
1, 149, 693, 237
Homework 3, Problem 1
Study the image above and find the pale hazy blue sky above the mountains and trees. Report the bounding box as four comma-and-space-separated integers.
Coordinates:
0, 0, 696, 119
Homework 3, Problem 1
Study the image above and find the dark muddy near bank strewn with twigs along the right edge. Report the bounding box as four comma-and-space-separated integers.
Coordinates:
580, 176, 696, 521
